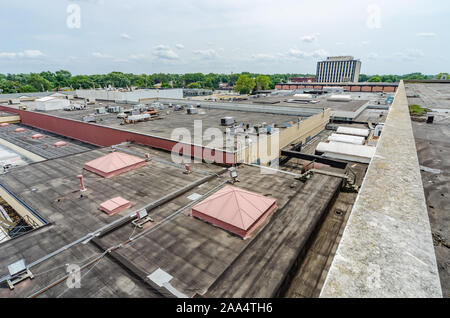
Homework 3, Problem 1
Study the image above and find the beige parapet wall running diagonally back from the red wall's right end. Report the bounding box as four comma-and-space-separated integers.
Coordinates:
236, 109, 331, 166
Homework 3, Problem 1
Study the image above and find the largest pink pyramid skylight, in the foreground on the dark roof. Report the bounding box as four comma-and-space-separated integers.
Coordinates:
192, 186, 277, 238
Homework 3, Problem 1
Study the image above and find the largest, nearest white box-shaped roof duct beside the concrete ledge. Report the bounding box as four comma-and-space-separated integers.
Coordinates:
316, 141, 376, 163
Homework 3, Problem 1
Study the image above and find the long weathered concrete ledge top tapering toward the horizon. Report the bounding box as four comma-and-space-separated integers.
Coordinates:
320, 82, 442, 298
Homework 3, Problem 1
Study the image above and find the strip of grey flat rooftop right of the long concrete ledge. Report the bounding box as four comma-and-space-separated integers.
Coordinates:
405, 83, 450, 298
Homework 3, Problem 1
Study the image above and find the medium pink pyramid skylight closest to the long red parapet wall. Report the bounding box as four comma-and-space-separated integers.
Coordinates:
84, 151, 146, 178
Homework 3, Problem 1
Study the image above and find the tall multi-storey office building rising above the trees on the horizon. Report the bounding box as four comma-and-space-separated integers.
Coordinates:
316, 56, 361, 83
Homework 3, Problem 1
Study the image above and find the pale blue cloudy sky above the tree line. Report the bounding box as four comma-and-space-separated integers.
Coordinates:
0, 0, 450, 74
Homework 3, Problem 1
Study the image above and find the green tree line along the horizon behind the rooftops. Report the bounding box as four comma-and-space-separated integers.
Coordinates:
0, 70, 448, 94
